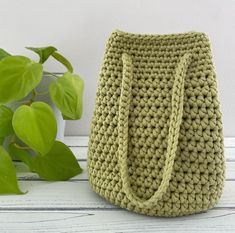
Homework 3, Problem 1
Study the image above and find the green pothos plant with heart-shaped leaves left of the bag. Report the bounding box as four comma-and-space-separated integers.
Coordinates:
0, 46, 84, 194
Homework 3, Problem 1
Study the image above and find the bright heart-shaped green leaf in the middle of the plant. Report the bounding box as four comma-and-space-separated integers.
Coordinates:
12, 102, 57, 155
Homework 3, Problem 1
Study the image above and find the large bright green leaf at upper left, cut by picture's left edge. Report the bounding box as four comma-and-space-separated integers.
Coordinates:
0, 56, 42, 104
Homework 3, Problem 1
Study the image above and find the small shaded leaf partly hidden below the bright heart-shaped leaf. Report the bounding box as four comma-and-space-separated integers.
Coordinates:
9, 143, 34, 171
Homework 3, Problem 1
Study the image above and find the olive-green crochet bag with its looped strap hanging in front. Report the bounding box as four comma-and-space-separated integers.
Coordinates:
88, 31, 225, 216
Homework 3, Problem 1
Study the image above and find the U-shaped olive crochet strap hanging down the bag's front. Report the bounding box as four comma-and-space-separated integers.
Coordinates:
117, 53, 191, 208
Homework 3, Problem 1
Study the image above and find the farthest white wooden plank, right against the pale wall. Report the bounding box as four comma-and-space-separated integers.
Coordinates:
65, 136, 235, 147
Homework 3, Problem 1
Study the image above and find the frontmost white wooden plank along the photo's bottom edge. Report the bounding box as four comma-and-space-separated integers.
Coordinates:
0, 209, 235, 233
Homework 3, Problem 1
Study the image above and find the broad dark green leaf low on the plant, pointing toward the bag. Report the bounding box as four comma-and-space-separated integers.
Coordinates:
34, 141, 82, 181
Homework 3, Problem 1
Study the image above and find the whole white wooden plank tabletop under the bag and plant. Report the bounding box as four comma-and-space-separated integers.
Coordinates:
0, 137, 235, 233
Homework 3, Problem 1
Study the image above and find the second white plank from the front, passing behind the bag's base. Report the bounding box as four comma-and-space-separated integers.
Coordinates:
0, 181, 235, 210
